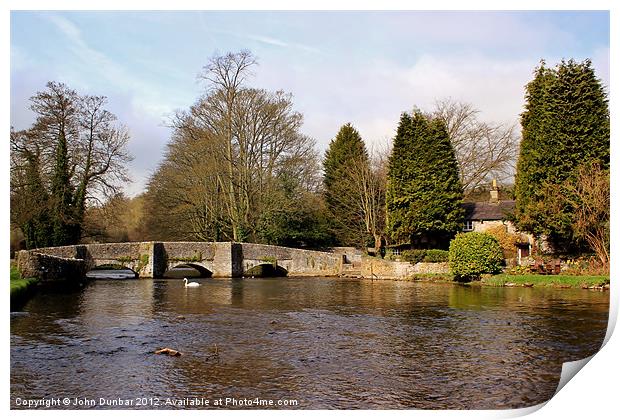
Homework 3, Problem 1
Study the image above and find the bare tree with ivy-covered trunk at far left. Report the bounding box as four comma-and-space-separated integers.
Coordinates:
11, 82, 131, 245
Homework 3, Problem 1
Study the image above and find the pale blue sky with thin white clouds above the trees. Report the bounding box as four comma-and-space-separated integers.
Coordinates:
10, 11, 610, 195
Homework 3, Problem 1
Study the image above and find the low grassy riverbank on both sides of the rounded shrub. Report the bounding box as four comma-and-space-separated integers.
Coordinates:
407, 273, 609, 289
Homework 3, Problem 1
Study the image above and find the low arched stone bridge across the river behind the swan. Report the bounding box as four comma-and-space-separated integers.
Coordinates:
17, 242, 345, 280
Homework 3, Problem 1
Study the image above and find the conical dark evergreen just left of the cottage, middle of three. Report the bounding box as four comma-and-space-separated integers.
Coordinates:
386, 111, 463, 248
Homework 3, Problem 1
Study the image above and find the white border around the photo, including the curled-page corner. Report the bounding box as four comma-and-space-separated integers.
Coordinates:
0, 0, 620, 419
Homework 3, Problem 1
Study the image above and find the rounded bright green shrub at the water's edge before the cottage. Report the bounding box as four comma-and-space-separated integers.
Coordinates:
449, 232, 504, 281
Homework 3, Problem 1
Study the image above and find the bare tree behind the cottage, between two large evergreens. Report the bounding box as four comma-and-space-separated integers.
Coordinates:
431, 99, 519, 191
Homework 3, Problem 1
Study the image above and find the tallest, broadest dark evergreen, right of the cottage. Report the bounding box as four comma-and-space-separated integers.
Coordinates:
515, 60, 609, 250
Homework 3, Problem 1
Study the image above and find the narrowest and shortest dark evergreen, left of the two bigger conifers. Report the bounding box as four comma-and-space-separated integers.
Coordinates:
323, 124, 370, 246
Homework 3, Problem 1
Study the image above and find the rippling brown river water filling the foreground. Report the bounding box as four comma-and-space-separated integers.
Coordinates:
11, 278, 609, 409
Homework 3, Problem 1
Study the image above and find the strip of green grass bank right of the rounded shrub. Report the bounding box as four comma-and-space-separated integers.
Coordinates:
481, 274, 609, 288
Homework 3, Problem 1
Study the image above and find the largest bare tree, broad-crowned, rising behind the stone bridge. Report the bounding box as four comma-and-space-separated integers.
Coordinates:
147, 52, 319, 241
